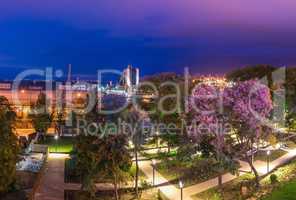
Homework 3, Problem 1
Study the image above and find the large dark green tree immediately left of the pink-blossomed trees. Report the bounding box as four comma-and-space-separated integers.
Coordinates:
140, 73, 185, 152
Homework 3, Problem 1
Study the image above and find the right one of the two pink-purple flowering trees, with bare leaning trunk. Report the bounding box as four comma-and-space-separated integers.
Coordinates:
223, 80, 273, 187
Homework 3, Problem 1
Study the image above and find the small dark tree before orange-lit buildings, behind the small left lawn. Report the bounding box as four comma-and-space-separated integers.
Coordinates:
30, 93, 53, 140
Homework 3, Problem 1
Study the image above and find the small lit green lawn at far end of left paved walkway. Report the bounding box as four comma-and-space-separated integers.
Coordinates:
40, 136, 76, 153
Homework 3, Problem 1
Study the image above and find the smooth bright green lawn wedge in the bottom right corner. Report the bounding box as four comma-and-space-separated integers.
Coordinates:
264, 181, 296, 200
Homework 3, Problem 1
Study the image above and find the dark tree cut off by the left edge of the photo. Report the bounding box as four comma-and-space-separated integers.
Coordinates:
0, 97, 19, 196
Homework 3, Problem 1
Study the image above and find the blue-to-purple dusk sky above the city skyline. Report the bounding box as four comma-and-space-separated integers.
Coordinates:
0, 0, 296, 79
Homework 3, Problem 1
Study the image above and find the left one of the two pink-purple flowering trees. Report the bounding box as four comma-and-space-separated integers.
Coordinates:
189, 84, 238, 186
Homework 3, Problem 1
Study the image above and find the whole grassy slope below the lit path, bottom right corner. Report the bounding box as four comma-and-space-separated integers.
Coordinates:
192, 159, 296, 200
